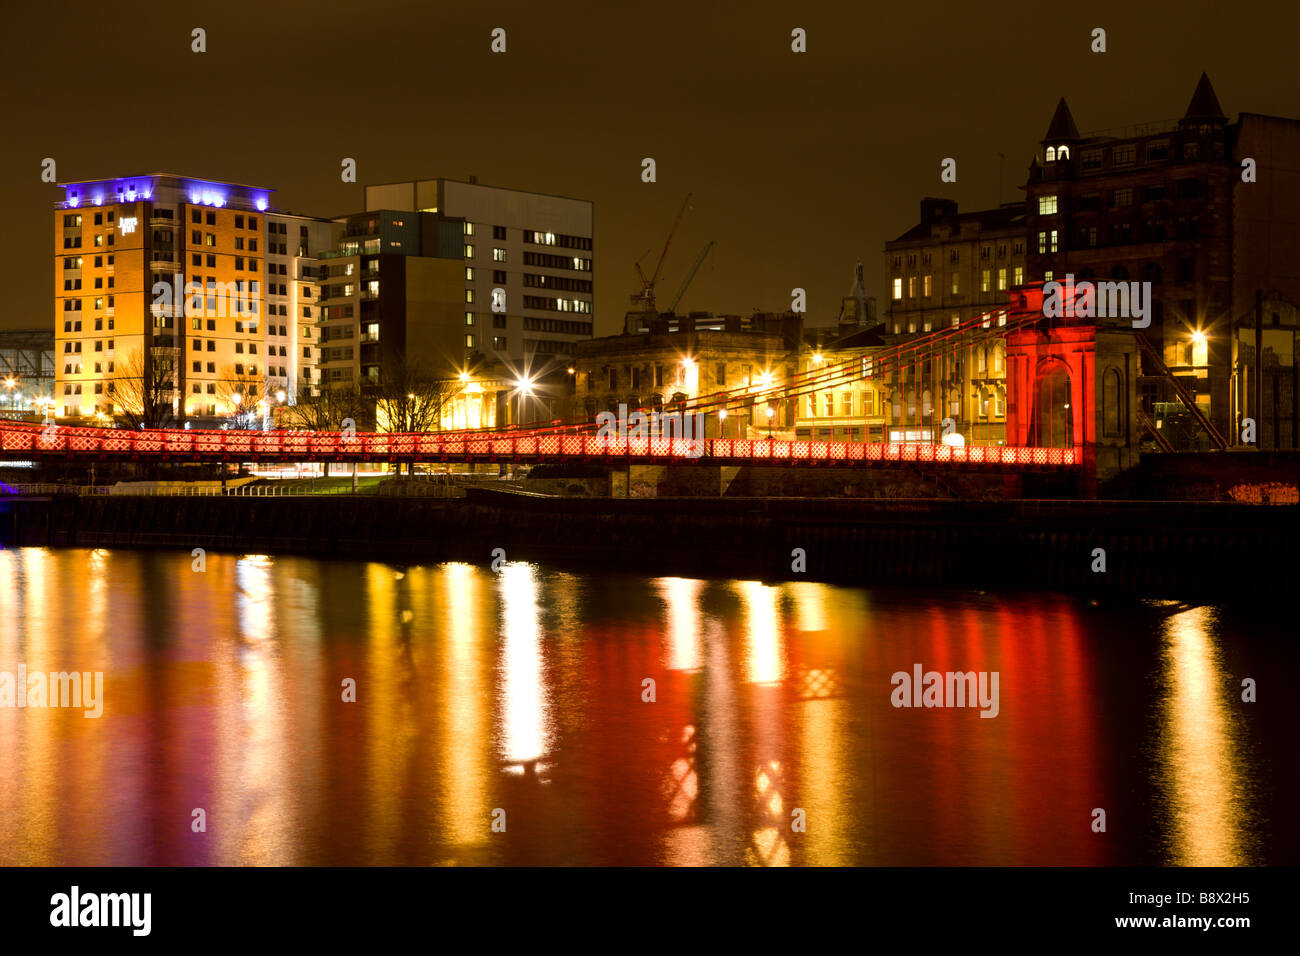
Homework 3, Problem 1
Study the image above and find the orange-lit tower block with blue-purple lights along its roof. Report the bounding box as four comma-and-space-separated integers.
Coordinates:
53, 173, 270, 424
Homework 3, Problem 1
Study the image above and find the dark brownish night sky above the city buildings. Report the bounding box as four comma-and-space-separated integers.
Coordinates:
0, 0, 1300, 334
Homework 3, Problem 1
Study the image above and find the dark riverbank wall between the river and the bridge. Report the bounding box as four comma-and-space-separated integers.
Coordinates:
0, 489, 1300, 602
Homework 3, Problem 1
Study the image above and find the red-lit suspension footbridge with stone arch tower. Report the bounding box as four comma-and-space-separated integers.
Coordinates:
0, 286, 1118, 472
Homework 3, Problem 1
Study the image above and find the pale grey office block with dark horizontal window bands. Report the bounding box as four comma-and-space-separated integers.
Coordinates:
365, 177, 595, 375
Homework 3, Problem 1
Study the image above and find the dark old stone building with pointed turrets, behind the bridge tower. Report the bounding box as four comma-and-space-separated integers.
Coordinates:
1026, 74, 1300, 447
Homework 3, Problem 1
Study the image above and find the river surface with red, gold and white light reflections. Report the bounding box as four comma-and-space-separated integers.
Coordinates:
0, 549, 1300, 865
